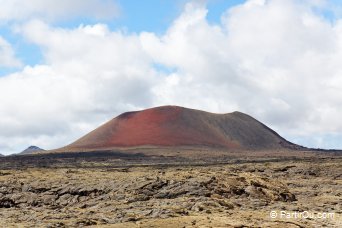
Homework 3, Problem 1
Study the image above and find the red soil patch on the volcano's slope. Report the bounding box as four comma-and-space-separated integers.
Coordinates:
107, 107, 238, 147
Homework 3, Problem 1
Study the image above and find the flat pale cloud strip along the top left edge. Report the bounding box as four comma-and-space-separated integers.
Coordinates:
0, 0, 119, 21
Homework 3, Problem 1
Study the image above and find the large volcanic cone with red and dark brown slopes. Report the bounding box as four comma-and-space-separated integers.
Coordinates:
59, 106, 301, 151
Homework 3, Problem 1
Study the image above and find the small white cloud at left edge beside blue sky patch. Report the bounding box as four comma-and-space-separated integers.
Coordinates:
0, 36, 22, 67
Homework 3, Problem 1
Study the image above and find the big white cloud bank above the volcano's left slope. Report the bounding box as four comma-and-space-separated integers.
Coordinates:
0, 20, 158, 153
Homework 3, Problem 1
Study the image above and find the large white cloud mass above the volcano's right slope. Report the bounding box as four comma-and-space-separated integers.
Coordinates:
142, 0, 342, 144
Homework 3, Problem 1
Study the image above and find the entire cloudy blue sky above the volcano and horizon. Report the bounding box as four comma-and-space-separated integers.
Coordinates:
0, 0, 342, 154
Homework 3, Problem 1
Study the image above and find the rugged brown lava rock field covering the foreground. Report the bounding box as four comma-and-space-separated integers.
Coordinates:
0, 156, 342, 227
